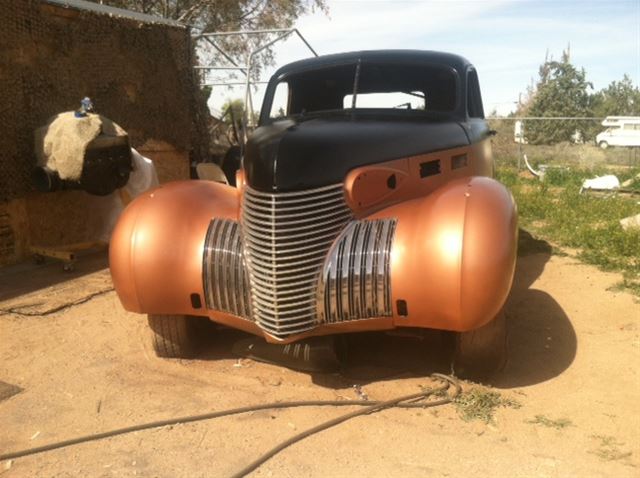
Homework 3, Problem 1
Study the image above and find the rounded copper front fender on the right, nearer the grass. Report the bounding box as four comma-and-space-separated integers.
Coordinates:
371, 177, 517, 331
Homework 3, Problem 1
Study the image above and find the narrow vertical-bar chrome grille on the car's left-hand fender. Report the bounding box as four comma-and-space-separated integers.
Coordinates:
202, 219, 251, 319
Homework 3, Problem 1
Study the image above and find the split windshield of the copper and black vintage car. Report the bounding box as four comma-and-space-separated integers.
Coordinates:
269, 62, 458, 119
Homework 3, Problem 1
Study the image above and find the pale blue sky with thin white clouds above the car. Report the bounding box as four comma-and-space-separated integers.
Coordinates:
209, 0, 640, 114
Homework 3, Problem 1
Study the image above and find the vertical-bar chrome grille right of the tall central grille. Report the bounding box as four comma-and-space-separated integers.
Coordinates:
318, 219, 397, 323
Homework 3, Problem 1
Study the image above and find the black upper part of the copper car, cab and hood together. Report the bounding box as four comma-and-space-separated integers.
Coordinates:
243, 50, 498, 192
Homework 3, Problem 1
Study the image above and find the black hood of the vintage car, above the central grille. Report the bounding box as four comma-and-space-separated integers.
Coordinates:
244, 118, 469, 192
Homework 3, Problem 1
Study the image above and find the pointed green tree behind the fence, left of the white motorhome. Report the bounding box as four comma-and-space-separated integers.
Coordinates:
526, 50, 593, 144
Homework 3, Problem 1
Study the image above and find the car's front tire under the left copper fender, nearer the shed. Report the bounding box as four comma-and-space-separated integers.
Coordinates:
147, 314, 195, 358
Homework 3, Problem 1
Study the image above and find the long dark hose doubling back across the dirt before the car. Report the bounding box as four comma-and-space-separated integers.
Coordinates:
0, 373, 462, 478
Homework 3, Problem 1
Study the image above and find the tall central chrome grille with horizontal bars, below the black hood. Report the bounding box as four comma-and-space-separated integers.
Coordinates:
242, 184, 351, 338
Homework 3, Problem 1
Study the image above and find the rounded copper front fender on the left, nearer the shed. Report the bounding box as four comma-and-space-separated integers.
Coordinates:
109, 181, 239, 314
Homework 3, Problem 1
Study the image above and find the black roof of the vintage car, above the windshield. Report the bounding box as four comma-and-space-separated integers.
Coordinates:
273, 50, 471, 78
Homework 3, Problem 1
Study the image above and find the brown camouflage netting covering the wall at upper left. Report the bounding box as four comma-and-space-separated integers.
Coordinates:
0, 0, 206, 202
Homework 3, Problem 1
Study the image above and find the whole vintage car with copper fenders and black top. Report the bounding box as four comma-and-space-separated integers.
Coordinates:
110, 50, 517, 373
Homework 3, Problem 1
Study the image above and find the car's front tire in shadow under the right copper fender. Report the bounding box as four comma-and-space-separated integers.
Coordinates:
452, 310, 507, 381
